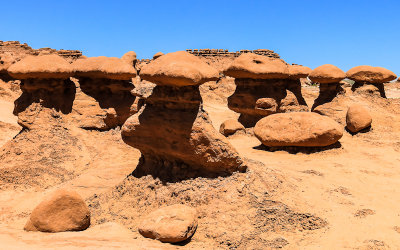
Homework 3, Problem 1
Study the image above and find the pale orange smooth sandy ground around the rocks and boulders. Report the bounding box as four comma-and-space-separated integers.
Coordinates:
0, 80, 400, 249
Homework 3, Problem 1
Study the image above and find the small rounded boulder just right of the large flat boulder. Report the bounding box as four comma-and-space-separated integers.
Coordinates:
346, 104, 372, 133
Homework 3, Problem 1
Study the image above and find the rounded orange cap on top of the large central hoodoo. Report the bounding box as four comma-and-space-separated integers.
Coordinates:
140, 51, 219, 87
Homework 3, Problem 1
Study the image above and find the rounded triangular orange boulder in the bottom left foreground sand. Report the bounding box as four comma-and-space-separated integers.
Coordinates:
24, 190, 90, 233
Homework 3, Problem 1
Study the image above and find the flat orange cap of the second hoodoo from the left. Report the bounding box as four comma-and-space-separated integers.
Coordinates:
72, 56, 136, 80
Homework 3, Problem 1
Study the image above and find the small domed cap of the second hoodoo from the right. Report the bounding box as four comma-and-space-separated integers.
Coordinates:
308, 64, 346, 83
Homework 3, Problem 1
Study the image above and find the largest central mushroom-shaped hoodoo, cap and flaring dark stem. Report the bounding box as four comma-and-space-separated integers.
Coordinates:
122, 51, 246, 180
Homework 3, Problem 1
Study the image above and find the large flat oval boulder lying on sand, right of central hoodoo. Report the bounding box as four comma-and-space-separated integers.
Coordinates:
254, 112, 343, 147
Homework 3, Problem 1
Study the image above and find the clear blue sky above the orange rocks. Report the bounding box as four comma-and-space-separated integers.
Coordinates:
0, 0, 400, 74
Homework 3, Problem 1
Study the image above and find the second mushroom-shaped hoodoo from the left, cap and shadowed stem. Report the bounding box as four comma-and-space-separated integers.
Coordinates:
72, 56, 140, 130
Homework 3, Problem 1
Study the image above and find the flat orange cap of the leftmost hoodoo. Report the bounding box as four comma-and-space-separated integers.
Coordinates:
8, 55, 74, 79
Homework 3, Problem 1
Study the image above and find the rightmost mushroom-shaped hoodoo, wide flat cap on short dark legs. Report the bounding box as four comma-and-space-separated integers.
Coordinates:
346, 65, 397, 98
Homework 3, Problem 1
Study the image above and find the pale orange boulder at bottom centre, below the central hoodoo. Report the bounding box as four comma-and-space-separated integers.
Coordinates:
139, 204, 197, 243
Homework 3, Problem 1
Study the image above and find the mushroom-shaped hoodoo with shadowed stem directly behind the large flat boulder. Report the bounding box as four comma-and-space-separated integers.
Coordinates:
224, 53, 308, 127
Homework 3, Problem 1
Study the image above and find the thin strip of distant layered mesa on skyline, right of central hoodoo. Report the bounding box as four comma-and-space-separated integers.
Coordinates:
186, 49, 279, 58
